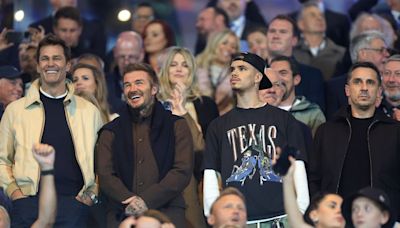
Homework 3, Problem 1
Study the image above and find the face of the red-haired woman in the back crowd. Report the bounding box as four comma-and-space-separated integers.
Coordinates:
144, 23, 168, 54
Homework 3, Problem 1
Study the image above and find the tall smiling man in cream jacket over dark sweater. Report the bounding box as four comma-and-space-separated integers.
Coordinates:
0, 35, 102, 227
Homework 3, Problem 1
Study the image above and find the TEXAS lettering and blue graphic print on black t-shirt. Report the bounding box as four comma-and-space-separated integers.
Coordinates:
226, 124, 282, 186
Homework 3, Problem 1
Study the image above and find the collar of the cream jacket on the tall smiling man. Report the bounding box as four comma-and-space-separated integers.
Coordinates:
25, 79, 75, 108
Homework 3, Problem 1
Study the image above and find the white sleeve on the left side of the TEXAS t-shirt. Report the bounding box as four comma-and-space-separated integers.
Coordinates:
203, 169, 219, 217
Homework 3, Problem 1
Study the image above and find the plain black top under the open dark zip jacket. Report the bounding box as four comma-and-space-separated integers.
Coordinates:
339, 117, 373, 198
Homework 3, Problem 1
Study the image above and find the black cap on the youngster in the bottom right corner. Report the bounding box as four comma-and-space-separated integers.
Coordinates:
342, 187, 396, 228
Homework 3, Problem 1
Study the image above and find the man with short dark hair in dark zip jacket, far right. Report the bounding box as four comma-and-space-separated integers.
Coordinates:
309, 62, 400, 220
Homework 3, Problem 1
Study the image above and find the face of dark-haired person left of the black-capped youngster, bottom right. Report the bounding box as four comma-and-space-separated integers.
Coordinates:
310, 194, 345, 228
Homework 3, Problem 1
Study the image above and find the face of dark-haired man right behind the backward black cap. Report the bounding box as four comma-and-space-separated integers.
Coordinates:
258, 68, 286, 106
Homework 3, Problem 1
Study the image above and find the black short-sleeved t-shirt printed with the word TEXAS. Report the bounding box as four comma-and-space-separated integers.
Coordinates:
204, 105, 306, 220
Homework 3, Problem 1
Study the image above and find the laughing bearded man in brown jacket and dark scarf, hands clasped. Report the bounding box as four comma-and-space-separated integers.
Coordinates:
96, 63, 193, 228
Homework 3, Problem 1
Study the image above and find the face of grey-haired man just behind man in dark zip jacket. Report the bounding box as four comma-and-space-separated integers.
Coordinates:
358, 38, 389, 72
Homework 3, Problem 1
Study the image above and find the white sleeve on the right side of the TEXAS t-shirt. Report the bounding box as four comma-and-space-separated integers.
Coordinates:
294, 160, 310, 214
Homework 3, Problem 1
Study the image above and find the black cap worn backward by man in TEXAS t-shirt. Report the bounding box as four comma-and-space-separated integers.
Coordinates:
231, 52, 272, 89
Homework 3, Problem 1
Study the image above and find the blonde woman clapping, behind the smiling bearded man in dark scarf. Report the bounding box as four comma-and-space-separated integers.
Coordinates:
158, 47, 218, 227
